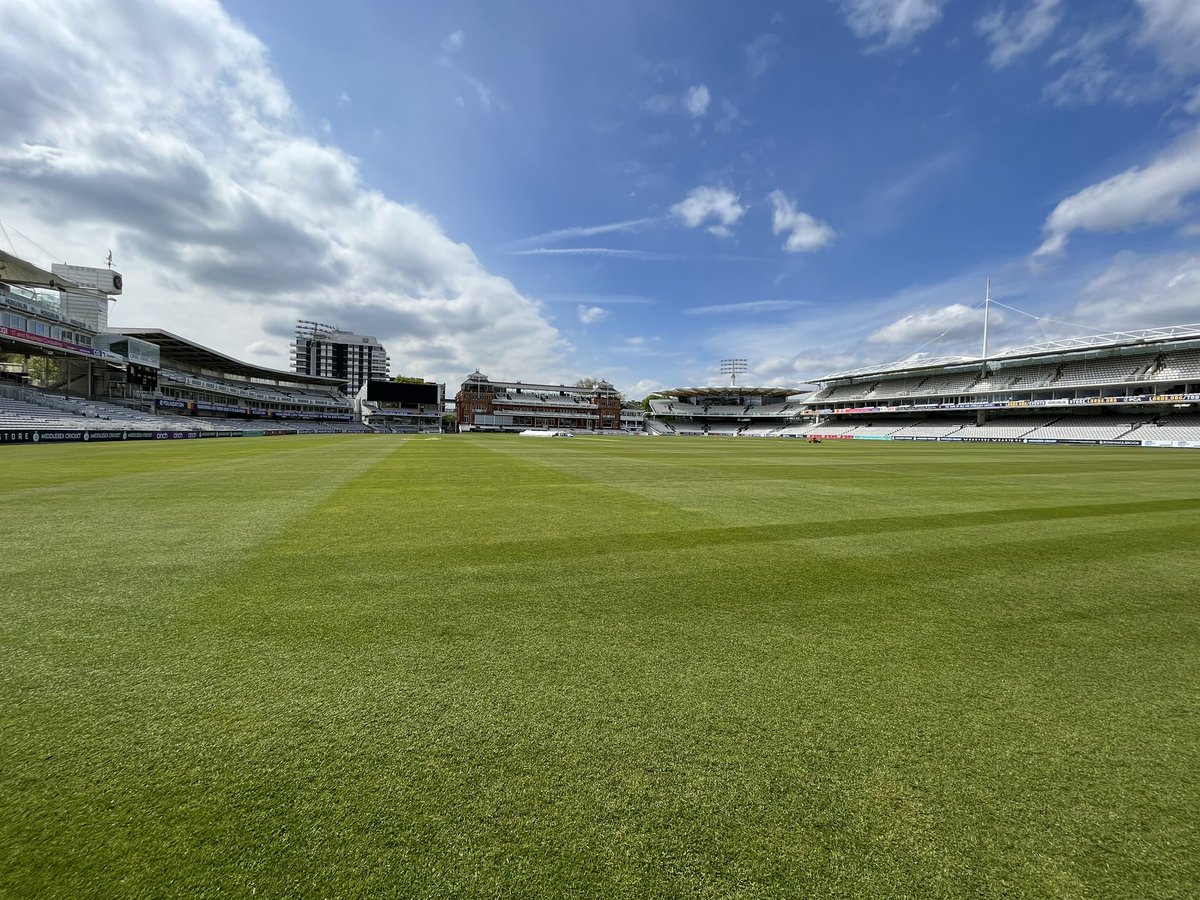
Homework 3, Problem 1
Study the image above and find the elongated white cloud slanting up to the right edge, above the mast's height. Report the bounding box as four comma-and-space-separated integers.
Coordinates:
1034, 126, 1200, 256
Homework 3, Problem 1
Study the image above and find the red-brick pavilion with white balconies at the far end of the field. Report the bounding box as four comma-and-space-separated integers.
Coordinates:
455, 371, 640, 431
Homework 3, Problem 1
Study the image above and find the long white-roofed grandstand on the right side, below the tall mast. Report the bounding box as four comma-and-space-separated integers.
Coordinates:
808, 325, 1200, 446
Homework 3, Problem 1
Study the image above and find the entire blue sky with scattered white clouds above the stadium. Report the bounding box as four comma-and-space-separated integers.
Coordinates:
0, 0, 1200, 396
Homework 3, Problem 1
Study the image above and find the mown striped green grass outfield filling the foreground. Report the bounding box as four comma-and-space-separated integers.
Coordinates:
0, 436, 1200, 898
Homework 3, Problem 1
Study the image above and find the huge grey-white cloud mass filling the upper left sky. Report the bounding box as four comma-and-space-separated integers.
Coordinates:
0, 0, 565, 380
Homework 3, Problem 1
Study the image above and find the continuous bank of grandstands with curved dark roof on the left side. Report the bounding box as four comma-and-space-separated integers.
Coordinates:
0, 253, 368, 433
